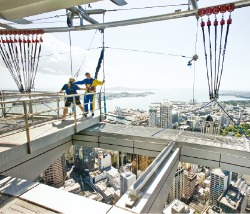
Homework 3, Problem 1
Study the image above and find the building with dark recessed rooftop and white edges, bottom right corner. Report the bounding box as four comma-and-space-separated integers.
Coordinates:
218, 186, 246, 213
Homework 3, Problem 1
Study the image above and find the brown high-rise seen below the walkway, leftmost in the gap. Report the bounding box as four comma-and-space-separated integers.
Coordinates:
43, 155, 66, 187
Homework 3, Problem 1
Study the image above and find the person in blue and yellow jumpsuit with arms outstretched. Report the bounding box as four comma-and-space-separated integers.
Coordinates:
74, 72, 105, 116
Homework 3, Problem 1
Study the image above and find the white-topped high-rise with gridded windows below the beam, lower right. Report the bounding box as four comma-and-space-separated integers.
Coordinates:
209, 169, 228, 205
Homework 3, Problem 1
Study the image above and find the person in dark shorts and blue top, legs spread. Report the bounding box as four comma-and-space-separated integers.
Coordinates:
59, 78, 86, 120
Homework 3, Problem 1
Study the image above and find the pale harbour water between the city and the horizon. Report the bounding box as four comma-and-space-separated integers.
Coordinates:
106, 89, 247, 111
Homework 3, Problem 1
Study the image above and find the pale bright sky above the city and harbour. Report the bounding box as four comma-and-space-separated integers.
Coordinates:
0, 0, 250, 91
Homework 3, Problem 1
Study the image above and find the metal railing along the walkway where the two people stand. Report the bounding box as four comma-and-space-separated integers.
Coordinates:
0, 91, 105, 154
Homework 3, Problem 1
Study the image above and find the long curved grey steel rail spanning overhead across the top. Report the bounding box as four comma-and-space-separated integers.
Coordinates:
0, 0, 250, 33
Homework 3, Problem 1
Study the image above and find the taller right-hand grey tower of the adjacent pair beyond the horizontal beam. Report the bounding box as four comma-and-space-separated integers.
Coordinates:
160, 101, 173, 129
